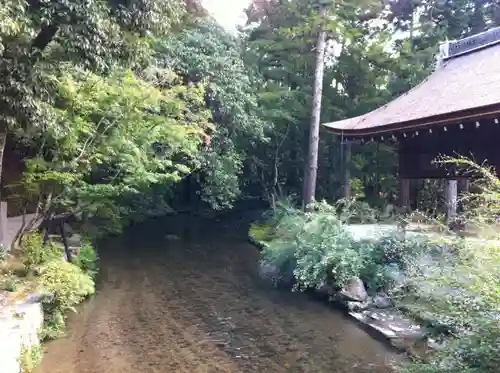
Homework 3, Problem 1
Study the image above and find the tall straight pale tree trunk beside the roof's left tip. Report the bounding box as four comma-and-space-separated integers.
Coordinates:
303, 8, 326, 208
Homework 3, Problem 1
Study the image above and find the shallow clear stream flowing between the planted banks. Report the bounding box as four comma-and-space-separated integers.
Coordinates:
36, 212, 397, 373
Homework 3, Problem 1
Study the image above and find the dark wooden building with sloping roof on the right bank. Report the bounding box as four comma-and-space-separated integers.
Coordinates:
324, 28, 500, 215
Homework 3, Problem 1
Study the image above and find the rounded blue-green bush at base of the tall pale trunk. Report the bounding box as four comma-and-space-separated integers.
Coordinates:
262, 203, 362, 289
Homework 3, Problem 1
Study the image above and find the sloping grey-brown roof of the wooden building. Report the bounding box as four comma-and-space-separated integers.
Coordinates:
323, 30, 500, 136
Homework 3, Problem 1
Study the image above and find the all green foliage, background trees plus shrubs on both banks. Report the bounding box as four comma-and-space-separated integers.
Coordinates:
0, 0, 500, 373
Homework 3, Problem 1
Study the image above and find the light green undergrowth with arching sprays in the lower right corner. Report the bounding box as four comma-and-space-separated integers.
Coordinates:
403, 158, 500, 373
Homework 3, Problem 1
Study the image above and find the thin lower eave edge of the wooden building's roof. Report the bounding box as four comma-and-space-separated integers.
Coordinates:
322, 103, 500, 137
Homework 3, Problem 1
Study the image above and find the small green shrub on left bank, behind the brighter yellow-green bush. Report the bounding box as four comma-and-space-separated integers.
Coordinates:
20, 233, 62, 269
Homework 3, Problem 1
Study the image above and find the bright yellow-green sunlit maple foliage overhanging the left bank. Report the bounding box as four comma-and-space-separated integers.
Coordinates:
24, 66, 210, 221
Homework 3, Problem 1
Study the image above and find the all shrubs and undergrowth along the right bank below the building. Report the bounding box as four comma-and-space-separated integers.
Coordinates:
250, 158, 500, 373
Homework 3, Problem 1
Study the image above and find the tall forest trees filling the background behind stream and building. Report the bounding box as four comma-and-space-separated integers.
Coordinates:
0, 0, 500, 229
